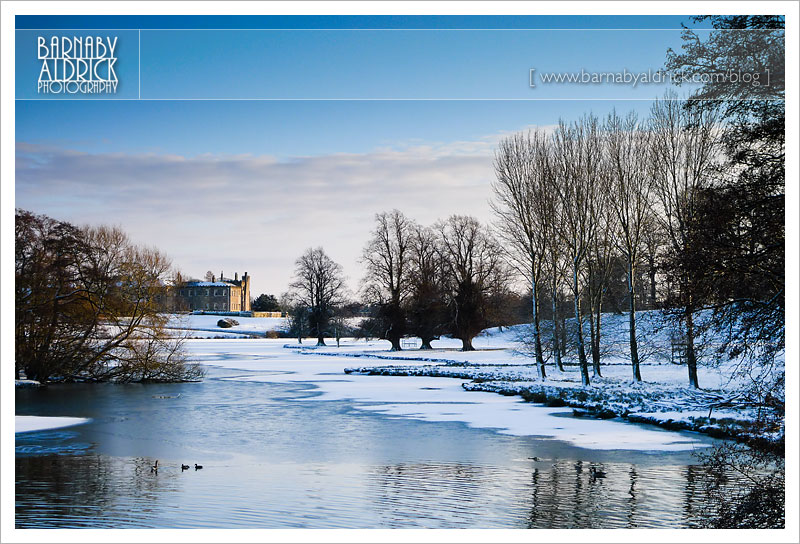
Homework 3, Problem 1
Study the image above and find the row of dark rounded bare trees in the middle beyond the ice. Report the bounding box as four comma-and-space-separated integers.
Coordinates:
281, 217, 527, 351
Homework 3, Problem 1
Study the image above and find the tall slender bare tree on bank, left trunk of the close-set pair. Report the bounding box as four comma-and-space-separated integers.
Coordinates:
552, 116, 601, 385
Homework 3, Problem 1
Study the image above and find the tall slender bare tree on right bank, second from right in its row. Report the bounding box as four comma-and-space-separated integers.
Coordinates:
605, 111, 655, 382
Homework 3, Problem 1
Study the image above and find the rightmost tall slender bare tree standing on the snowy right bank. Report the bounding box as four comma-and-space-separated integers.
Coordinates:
651, 95, 719, 387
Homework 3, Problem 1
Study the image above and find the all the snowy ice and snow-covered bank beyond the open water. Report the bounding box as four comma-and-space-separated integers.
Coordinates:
161, 312, 780, 450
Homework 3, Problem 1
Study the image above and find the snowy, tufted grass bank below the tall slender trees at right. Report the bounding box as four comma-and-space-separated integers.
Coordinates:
344, 362, 776, 441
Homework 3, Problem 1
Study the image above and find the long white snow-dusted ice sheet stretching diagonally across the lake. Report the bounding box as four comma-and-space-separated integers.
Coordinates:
189, 340, 708, 451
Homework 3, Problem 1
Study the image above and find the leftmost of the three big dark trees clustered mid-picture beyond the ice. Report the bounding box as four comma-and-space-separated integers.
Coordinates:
361, 210, 412, 351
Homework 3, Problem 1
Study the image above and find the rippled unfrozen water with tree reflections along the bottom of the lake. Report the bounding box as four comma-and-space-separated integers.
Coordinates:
16, 455, 716, 528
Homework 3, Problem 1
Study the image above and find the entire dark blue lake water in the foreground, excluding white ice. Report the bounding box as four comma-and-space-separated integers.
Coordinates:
16, 346, 720, 528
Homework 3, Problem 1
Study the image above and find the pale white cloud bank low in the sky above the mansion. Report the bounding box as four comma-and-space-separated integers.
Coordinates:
16, 140, 498, 294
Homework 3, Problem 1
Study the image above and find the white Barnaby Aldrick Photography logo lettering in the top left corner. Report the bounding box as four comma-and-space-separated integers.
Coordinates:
37, 36, 119, 94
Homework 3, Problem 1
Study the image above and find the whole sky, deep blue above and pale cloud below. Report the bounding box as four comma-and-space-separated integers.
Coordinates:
15, 16, 707, 296
